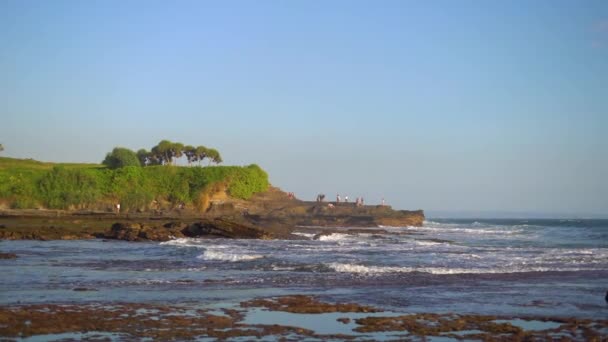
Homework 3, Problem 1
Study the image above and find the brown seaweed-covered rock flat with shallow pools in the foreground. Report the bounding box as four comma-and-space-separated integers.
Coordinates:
0, 295, 608, 341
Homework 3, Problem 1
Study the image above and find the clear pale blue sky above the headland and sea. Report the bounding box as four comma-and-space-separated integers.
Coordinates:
0, 0, 608, 217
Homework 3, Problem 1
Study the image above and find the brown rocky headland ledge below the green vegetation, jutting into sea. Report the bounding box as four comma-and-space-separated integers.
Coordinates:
0, 189, 424, 241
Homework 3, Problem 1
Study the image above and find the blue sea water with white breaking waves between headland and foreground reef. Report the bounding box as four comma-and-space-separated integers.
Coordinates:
0, 219, 608, 319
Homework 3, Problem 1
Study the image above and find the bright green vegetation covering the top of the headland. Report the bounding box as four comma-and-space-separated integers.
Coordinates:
0, 156, 269, 210
